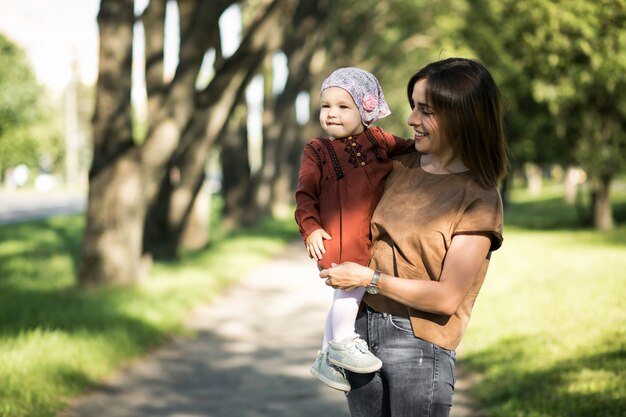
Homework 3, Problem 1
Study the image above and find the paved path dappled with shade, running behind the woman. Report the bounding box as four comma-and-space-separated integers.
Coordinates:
60, 242, 477, 417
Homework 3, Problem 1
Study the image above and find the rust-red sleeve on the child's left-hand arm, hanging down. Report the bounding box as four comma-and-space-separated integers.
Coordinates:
295, 144, 322, 240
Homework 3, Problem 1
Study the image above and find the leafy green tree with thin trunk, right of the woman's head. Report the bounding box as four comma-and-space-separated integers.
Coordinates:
464, 0, 626, 229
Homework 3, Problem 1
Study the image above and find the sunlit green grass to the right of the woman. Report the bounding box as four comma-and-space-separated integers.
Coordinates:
460, 183, 626, 417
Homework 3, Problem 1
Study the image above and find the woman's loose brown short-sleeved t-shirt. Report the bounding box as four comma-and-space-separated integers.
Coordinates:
364, 153, 502, 350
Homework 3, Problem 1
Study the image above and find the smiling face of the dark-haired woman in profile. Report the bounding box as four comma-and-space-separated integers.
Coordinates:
408, 79, 452, 156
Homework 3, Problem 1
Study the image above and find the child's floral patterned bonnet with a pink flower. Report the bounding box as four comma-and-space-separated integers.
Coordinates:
320, 67, 391, 127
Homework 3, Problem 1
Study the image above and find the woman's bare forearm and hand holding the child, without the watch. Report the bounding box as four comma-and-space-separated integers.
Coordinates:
320, 235, 491, 316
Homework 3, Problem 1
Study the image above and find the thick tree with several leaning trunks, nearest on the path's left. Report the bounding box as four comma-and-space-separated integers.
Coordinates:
79, 0, 293, 285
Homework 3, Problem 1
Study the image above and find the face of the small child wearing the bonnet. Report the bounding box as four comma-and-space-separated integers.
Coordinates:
320, 87, 365, 139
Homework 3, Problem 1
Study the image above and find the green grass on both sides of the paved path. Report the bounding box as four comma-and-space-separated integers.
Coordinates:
0, 185, 626, 417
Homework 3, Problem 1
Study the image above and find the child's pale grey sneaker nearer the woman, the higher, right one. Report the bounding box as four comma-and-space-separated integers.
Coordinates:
328, 334, 383, 374
